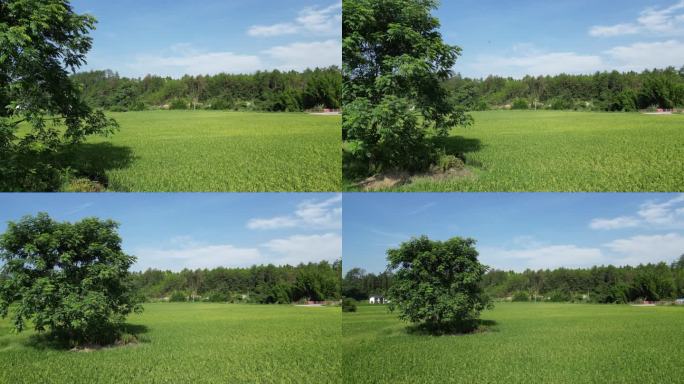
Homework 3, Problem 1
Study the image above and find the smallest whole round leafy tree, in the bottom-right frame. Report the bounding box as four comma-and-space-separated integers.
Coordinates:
387, 236, 491, 331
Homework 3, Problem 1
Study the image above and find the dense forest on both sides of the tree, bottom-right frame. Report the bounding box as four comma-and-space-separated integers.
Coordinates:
342, 255, 684, 303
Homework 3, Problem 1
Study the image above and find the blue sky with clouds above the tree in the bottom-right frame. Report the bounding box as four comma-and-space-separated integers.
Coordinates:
342, 193, 684, 272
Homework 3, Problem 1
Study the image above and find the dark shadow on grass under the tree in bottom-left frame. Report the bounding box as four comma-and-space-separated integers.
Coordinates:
25, 324, 150, 352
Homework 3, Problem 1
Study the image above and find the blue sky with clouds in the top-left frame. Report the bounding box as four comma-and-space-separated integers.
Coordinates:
72, 0, 342, 77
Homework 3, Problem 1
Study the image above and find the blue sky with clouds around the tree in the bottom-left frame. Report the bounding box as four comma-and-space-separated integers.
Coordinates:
0, 193, 342, 270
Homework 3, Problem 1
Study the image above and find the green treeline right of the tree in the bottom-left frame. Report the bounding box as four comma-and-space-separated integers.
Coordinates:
131, 261, 342, 304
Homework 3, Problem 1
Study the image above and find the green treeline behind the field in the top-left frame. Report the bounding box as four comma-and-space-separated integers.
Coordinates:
69, 67, 342, 112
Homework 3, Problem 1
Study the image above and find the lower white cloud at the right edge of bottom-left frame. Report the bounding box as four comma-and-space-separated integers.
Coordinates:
262, 233, 342, 265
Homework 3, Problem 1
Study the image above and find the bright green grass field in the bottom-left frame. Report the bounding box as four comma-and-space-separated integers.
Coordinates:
0, 303, 341, 384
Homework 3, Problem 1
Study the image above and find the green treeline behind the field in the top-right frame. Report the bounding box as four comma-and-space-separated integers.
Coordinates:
446, 67, 684, 112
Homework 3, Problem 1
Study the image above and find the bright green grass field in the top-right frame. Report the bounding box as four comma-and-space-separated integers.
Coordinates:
346, 111, 684, 192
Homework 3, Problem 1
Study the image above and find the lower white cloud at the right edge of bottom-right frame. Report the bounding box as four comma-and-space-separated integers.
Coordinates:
604, 233, 684, 265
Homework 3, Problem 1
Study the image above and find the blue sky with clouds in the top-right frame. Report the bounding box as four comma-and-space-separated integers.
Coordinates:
436, 0, 684, 77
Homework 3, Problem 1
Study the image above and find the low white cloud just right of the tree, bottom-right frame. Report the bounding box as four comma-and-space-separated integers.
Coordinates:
480, 245, 607, 271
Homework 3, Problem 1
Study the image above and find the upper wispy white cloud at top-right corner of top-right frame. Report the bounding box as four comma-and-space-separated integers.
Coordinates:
589, 0, 684, 37
